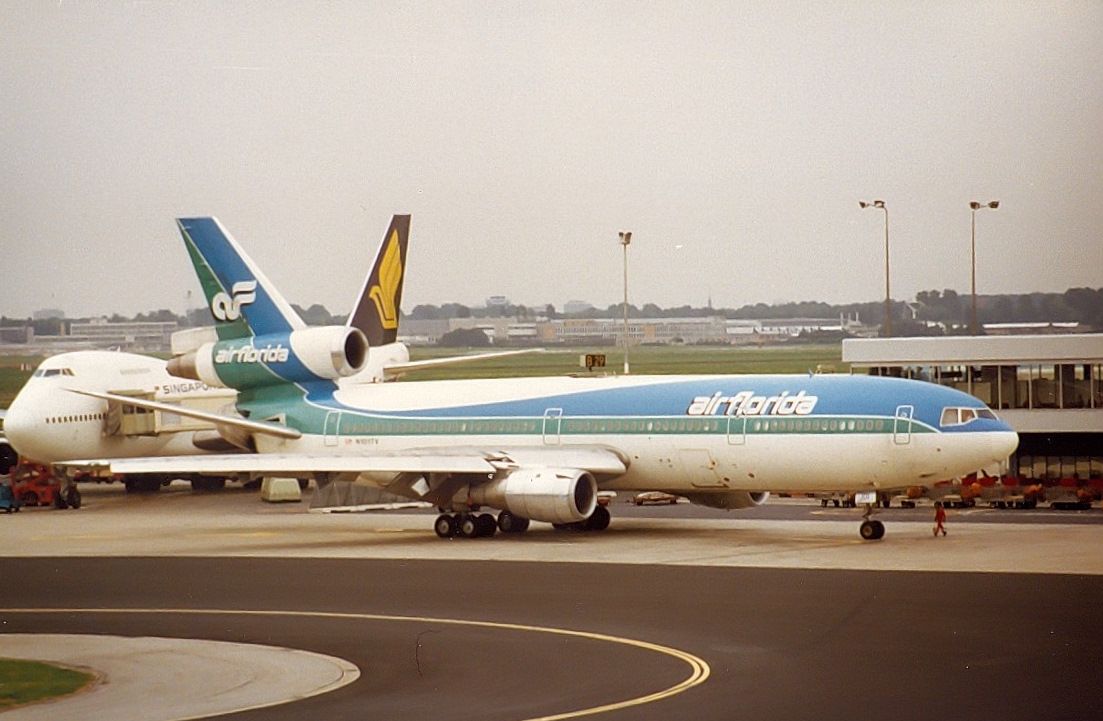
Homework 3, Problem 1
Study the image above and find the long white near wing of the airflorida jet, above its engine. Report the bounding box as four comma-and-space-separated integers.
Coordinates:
63, 446, 628, 476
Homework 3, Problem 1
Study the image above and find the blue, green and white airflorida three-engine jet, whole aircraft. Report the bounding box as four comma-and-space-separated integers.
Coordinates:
32, 218, 1018, 539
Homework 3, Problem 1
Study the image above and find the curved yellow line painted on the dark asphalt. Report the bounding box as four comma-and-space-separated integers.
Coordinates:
0, 609, 711, 721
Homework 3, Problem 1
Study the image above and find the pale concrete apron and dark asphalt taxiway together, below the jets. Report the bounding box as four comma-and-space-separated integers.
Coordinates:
0, 487, 1103, 720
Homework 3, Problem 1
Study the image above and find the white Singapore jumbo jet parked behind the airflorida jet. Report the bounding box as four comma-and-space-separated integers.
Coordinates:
6, 215, 533, 498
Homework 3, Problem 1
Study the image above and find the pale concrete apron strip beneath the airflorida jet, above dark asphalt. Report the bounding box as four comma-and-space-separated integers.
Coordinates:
0, 483, 1103, 574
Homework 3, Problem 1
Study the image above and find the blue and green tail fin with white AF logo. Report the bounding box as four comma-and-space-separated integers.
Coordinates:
176, 217, 306, 341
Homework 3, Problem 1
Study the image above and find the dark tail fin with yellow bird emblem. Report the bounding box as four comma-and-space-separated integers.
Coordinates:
345, 215, 410, 347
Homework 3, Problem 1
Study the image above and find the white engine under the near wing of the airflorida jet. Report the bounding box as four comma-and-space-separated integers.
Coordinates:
468, 469, 598, 524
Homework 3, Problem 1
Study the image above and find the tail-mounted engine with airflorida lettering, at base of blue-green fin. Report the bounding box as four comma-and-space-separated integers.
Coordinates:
168, 325, 367, 390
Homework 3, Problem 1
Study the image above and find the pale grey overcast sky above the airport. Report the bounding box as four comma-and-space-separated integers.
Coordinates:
0, 0, 1103, 316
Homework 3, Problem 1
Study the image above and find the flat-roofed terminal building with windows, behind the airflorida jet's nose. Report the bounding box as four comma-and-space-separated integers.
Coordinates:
843, 334, 1103, 501
